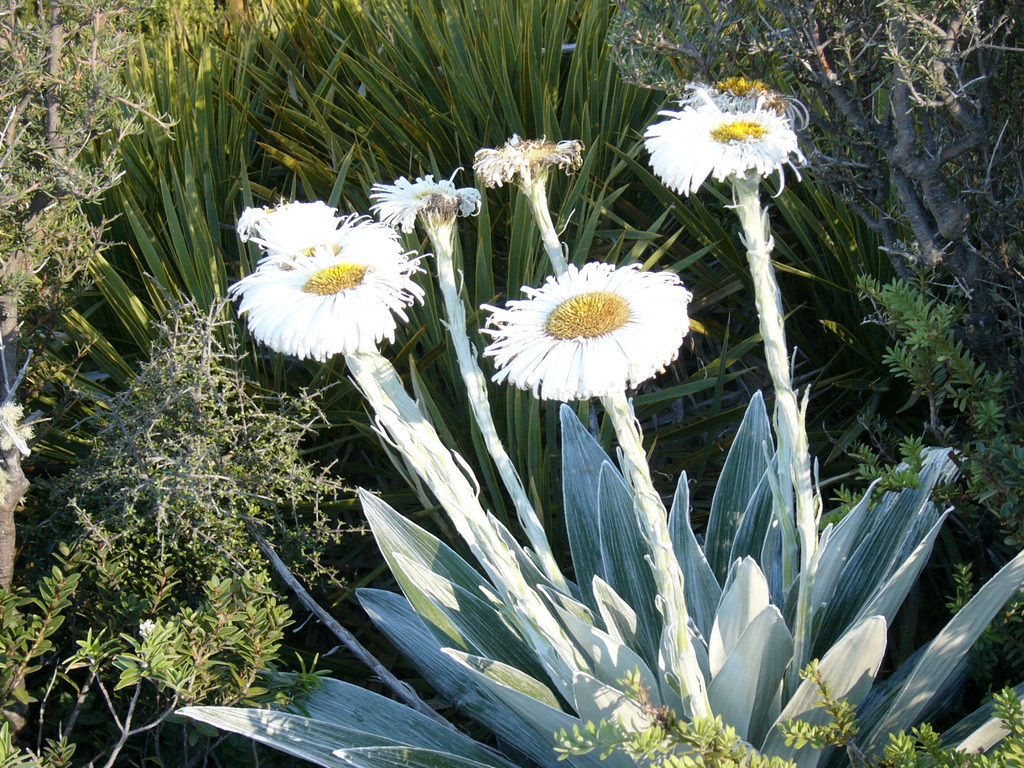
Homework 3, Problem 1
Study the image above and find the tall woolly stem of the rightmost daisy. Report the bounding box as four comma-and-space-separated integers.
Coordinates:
732, 173, 818, 683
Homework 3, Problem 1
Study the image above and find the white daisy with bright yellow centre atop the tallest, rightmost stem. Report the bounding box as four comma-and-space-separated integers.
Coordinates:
644, 101, 804, 195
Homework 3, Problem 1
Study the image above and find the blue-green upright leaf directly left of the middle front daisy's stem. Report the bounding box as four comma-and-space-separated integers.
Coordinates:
597, 463, 671, 664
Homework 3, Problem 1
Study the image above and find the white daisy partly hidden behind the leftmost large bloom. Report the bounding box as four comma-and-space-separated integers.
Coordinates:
238, 201, 341, 260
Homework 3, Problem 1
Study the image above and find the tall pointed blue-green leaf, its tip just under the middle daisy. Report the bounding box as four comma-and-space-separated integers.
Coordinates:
558, 406, 608, 607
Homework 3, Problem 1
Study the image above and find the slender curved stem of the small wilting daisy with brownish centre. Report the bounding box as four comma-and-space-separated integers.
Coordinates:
426, 220, 568, 593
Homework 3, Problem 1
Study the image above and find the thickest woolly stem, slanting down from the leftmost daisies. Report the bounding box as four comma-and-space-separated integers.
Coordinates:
345, 351, 588, 698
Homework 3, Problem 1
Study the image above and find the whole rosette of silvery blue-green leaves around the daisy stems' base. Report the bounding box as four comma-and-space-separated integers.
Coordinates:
182, 394, 1024, 768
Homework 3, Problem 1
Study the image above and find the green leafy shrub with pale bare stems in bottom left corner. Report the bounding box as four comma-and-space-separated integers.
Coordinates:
0, 546, 317, 768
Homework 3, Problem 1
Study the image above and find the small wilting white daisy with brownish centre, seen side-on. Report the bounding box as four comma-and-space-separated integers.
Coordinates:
370, 168, 480, 232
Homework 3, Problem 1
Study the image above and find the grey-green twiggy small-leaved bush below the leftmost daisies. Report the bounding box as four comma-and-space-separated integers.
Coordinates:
41, 305, 353, 590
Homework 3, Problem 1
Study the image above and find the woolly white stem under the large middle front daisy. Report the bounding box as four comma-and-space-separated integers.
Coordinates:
601, 391, 711, 718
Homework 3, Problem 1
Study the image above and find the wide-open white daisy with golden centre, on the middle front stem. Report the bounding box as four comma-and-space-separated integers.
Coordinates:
483, 262, 691, 401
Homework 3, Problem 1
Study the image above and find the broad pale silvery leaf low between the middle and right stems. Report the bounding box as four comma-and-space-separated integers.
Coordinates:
708, 605, 793, 743
